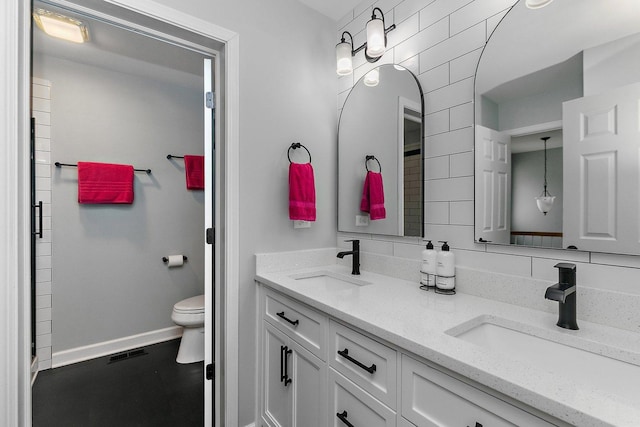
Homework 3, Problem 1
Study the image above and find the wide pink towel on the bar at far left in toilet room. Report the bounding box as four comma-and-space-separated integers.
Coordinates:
78, 162, 133, 204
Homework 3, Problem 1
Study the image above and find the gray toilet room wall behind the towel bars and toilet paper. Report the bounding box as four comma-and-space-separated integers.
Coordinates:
33, 55, 204, 352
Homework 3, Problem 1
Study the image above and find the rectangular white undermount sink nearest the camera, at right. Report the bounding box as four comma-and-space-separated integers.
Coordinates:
447, 316, 640, 405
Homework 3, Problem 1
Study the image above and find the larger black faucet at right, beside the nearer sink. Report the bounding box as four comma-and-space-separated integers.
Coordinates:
544, 262, 579, 330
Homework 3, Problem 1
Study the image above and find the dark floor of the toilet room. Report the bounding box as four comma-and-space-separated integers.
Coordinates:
32, 340, 204, 427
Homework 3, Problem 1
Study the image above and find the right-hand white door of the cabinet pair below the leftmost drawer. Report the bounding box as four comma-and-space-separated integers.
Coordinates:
289, 341, 327, 427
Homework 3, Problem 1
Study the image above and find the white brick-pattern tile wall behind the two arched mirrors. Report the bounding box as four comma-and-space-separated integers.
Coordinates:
336, 0, 640, 304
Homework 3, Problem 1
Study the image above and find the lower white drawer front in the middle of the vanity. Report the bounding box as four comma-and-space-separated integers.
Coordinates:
329, 369, 396, 427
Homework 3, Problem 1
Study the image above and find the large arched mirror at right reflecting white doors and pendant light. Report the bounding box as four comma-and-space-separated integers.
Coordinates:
475, 0, 640, 254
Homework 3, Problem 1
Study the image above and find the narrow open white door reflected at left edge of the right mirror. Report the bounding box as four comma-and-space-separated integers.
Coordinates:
475, 126, 511, 244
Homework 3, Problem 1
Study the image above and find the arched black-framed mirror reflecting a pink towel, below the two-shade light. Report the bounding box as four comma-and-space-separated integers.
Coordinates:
338, 64, 424, 237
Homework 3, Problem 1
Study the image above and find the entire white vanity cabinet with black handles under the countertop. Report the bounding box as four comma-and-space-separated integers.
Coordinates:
252, 286, 566, 427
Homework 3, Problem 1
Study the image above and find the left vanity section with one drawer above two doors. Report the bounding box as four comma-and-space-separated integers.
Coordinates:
259, 290, 327, 427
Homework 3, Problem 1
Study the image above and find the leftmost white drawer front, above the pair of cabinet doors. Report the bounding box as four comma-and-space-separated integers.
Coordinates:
264, 288, 328, 360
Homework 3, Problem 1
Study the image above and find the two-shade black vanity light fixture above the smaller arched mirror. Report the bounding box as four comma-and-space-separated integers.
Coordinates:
336, 7, 396, 76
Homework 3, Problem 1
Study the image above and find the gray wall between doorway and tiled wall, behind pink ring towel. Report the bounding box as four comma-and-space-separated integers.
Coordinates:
152, 0, 338, 426
